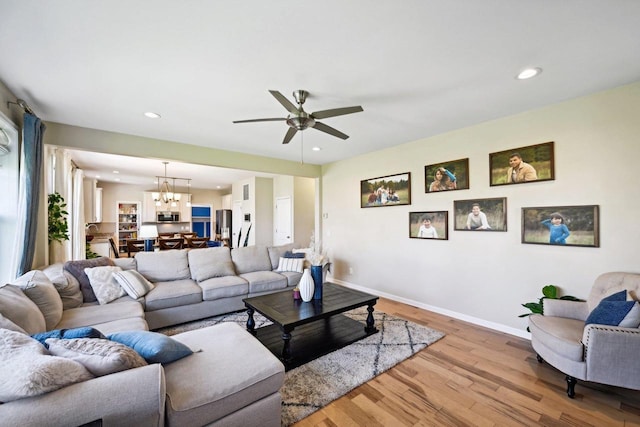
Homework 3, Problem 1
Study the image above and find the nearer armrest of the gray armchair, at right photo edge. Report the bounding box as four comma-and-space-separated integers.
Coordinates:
582, 324, 640, 390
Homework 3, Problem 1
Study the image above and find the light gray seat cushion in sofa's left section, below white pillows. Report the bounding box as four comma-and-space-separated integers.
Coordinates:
54, 301, 146, 334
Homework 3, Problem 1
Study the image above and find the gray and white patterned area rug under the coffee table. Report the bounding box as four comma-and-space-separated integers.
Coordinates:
156, 308, 444, 426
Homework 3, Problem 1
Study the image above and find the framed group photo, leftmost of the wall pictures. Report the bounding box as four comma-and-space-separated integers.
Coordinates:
360, 172, 411, 208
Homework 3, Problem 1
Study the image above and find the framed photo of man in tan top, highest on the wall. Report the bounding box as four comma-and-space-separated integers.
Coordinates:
489, 141, 555, 186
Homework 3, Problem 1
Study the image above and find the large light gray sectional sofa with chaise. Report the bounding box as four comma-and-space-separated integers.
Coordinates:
0, 245, 301, 426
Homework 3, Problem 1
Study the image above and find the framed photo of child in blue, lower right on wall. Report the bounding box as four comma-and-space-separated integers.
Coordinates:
522, 205, 600, 248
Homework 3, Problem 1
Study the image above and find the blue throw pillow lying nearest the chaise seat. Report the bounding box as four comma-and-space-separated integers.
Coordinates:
107, 331, 193, 363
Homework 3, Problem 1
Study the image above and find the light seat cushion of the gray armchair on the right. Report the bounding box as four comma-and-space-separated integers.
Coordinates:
529, 314, 584, 362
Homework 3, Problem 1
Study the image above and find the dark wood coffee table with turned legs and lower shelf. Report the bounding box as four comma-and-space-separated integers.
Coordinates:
243, 283, 378, 370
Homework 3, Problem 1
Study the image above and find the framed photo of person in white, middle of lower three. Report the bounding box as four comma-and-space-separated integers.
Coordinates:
453, 197, 507, 231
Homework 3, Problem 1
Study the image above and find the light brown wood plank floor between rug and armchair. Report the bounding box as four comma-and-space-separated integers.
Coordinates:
295, 298, 640, 427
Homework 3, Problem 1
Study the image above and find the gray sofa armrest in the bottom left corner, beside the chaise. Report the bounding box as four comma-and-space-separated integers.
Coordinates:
0, 364, 166, 427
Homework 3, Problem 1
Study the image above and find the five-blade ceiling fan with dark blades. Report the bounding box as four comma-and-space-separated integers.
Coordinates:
233, 90, 364, 144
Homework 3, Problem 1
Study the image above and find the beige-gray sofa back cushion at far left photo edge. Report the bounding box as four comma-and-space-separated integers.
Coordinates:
0, 285, 47, 334
